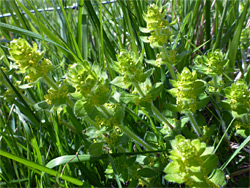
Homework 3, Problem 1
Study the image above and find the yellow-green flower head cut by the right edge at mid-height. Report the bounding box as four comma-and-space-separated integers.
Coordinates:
224, 79, 250, 114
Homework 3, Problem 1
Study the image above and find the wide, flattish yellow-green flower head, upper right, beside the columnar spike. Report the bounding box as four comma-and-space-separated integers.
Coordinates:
194, 50, 228, 76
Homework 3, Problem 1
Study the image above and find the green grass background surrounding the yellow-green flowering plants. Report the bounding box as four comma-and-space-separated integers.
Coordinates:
0, 0, 250, 187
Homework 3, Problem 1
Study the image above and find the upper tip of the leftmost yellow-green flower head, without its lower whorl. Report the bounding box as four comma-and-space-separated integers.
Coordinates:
9, 39, 44, 73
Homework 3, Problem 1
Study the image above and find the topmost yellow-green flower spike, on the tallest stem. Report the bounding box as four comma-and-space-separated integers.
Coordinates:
144, 4, 171, 47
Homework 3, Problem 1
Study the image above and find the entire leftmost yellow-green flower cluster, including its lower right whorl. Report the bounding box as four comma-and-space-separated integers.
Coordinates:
9, 39, 52, 82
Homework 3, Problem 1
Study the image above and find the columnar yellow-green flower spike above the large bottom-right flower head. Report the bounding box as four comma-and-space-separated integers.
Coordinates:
169, 67, 204, 112
